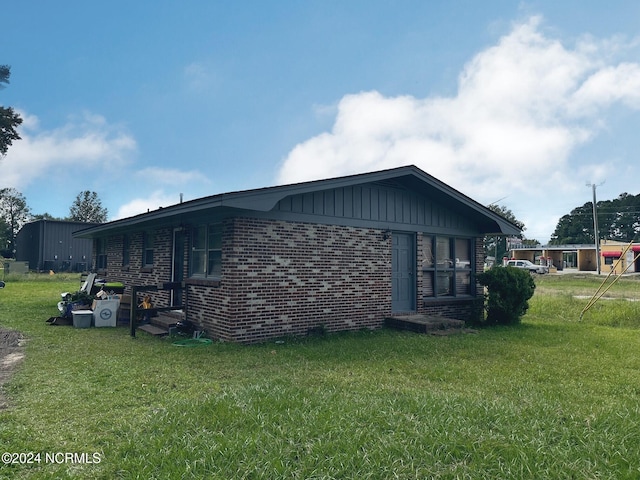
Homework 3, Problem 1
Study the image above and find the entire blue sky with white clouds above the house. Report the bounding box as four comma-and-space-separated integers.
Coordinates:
0, 0, 640, 243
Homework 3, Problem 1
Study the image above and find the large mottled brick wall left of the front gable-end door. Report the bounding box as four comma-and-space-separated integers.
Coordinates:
189, 218, 391, 342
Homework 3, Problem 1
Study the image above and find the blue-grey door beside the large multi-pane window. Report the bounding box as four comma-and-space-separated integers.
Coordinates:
391, 233, 416, 312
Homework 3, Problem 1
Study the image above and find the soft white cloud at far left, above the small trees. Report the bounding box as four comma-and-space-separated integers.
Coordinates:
0, 111, 137, 189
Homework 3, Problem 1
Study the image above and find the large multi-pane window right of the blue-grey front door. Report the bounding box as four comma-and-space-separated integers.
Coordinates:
421, 235, 474, 297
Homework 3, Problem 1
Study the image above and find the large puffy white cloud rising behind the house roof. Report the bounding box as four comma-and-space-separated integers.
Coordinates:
278, 17, 640, 241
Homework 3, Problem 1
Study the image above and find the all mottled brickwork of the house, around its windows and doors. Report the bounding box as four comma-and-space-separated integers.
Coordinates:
97, 218, 484, 343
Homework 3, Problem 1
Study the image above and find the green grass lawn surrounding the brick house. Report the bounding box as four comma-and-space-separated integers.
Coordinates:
0, 275, 640, 479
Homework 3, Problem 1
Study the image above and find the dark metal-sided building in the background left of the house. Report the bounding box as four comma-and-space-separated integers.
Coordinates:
16, 220, 99, 272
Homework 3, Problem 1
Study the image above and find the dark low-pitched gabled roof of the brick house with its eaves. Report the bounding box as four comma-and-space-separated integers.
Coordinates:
74, 165, 522, 238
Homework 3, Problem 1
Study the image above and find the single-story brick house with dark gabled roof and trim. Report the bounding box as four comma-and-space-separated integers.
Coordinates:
75, 166, 520, 343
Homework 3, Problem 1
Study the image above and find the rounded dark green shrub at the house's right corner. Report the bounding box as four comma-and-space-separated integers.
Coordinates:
477, 267, 536, 325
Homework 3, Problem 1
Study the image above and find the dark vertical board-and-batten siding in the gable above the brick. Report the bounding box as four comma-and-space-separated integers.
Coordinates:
274, 184, 475, 233
